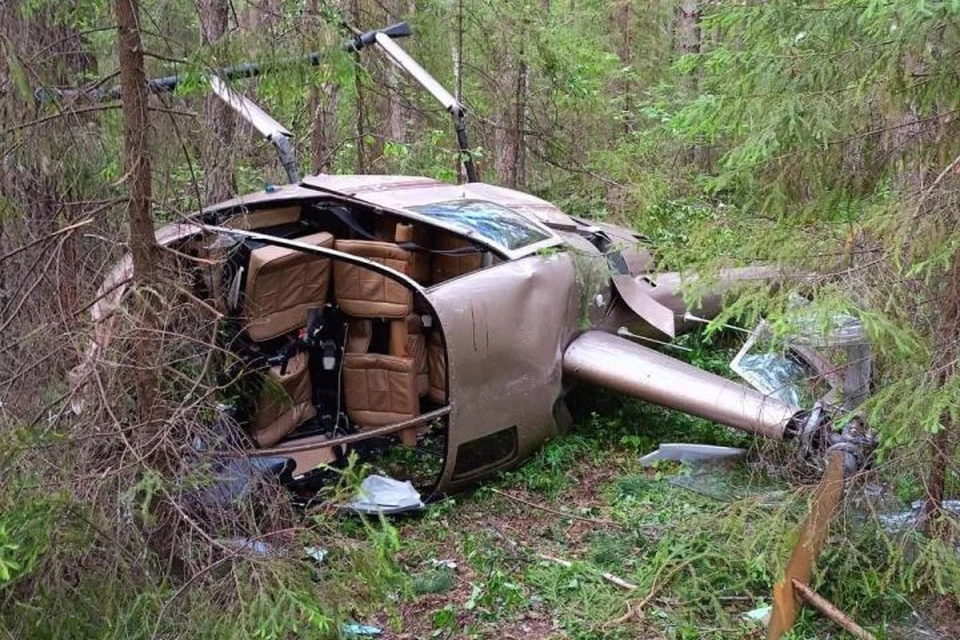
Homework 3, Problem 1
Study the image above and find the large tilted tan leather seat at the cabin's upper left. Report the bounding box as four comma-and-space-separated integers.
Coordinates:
243, 232, 333, 342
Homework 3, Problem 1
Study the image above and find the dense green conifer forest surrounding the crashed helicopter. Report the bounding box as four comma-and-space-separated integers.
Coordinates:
0, 0, 960, 637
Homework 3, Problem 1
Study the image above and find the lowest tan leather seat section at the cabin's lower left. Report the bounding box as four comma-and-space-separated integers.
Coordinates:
251, 353, 317, 447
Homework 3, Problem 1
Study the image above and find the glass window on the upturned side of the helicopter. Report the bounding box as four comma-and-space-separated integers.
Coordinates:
410, 199, 551, 251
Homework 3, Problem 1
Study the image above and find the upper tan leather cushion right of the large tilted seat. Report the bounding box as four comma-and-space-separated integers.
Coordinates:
333, 240, 413, 318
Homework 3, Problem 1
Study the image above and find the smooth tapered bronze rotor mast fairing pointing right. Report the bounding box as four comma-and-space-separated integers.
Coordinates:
563, 331, 797, 439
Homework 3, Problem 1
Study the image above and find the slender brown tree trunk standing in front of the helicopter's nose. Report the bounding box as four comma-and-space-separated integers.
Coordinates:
115, 0, 159, 423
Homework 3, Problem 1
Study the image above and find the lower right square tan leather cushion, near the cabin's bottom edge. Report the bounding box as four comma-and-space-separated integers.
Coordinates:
343, 353, 420, 427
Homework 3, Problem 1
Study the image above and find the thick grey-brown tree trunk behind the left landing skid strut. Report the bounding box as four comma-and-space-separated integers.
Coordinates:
199, 0, 237, 205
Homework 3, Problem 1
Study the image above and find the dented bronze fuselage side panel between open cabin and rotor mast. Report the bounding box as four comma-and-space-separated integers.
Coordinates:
427, 253, 579, 493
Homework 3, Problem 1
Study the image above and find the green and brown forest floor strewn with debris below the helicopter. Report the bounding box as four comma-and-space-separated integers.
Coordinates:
318, 390, 960, 639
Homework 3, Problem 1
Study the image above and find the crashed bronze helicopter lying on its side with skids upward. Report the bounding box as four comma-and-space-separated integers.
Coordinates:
52, 23, 870, 510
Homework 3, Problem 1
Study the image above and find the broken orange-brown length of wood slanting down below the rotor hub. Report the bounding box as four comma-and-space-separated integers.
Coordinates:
767, 451, 843, 640
